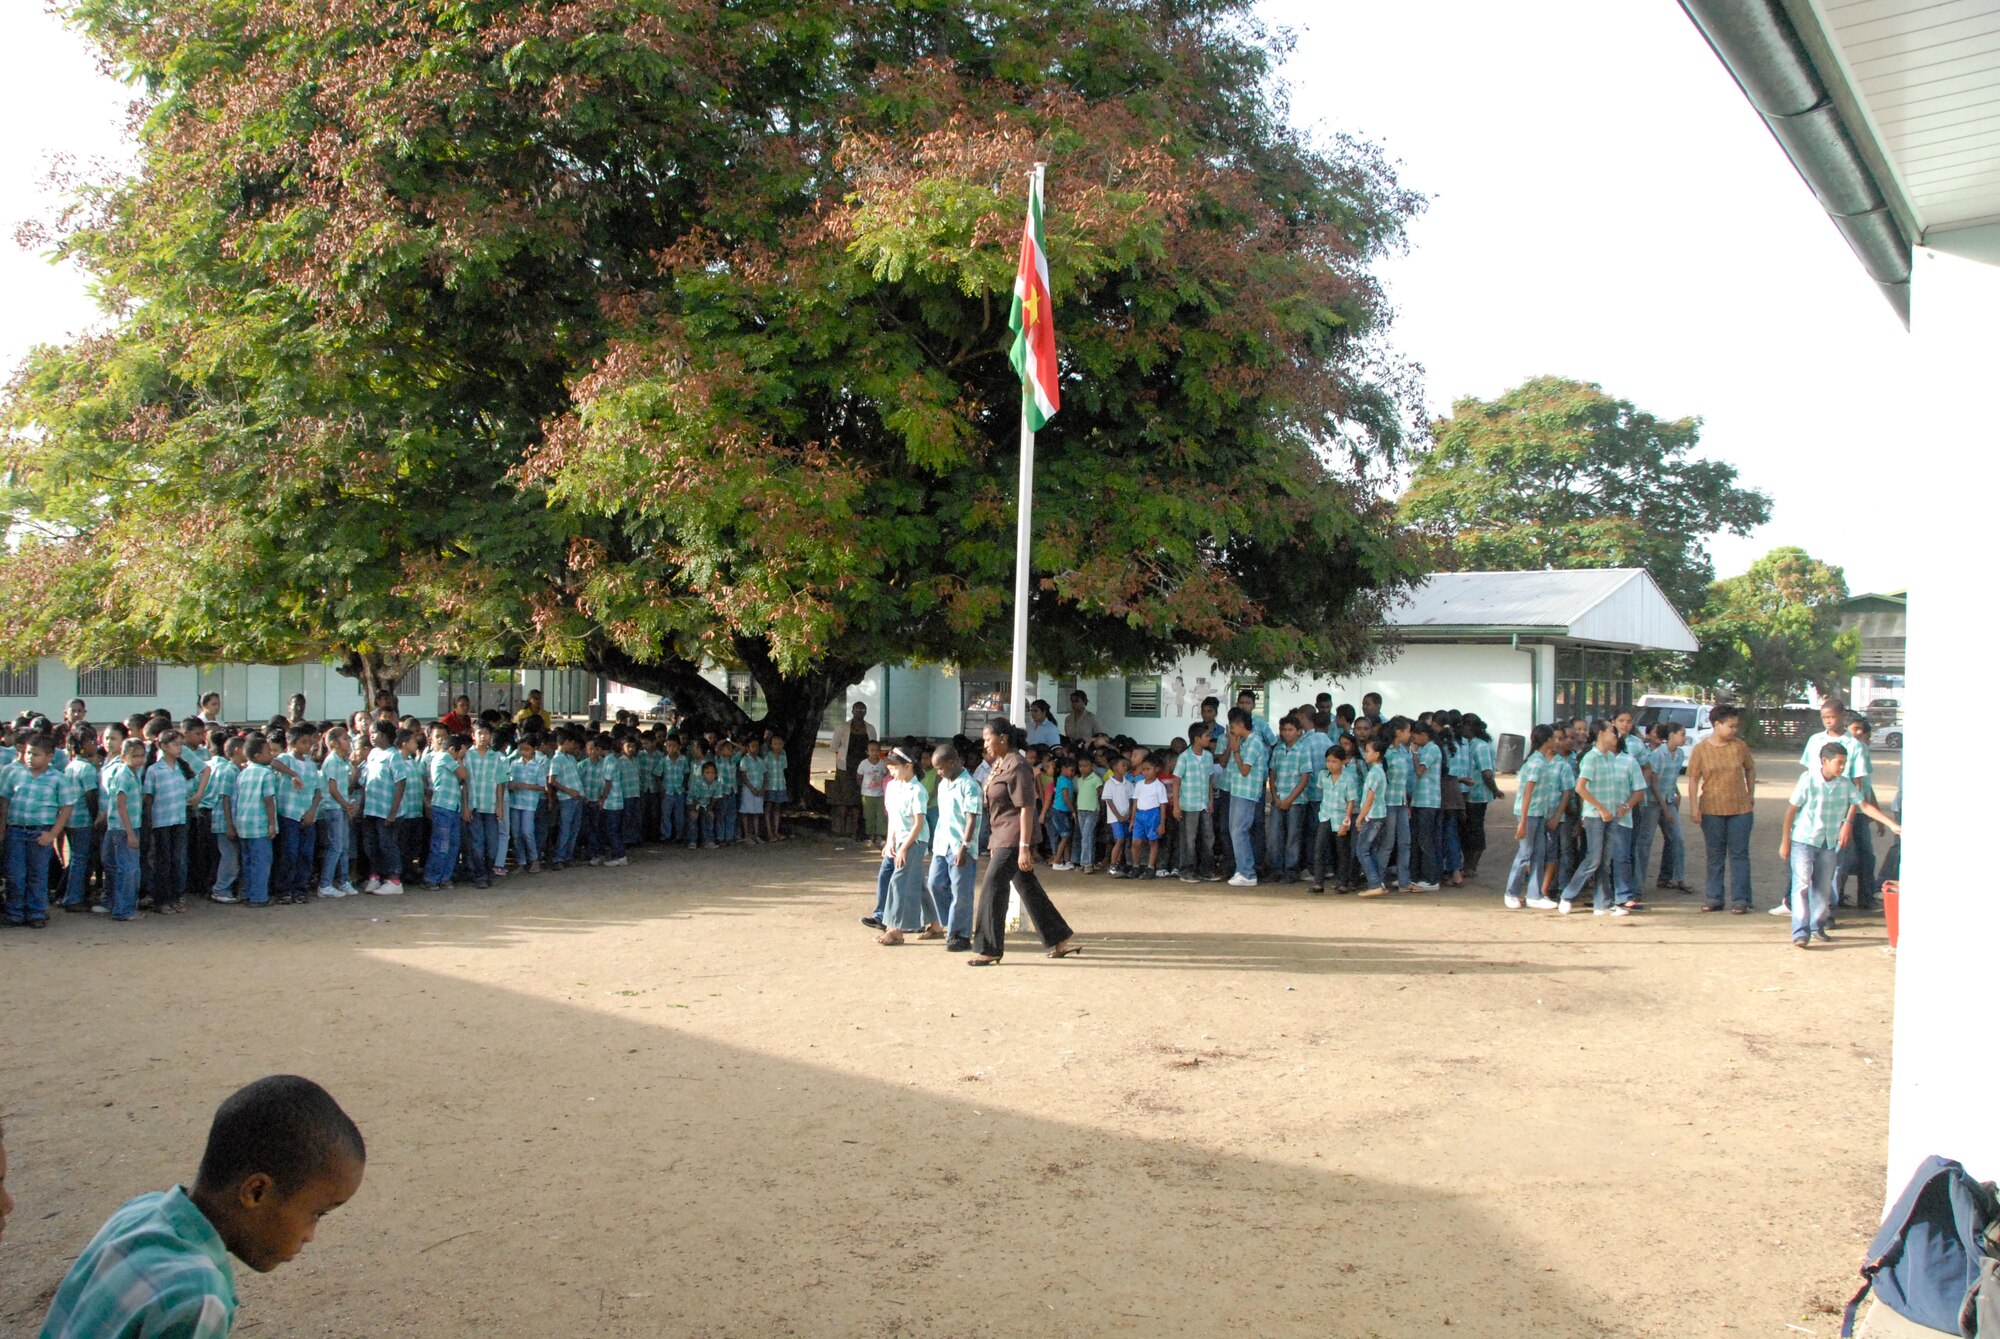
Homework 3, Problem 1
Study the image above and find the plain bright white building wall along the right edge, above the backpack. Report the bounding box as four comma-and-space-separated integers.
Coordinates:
1884, 250, 2000, 1201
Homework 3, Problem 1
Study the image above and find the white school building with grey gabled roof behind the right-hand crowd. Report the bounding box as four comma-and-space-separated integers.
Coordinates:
842, 568, 1696, 743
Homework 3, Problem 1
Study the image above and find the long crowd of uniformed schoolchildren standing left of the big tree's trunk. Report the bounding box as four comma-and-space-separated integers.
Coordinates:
0, 695, 790, 929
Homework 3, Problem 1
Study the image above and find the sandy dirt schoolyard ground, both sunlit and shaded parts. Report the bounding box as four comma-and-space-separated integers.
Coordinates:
0, 761, 1896, 1339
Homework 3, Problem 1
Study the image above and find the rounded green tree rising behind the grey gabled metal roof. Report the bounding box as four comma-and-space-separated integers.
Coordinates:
1402, 376, 1770, 620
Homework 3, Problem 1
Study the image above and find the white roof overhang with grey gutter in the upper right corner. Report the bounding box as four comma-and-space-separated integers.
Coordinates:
1680, 0, 2000, 326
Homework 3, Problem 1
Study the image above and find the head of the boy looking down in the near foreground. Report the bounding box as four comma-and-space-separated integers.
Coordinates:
192, 1079, 368, 1273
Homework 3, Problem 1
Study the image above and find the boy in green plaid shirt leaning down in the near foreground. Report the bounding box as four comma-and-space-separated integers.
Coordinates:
42, 1073, 368, 1339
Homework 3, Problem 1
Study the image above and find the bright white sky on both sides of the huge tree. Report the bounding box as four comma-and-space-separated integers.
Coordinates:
0, 0, 1920, 592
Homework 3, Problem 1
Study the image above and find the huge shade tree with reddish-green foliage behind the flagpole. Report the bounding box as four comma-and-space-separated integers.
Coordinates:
0, 0, 1418, 799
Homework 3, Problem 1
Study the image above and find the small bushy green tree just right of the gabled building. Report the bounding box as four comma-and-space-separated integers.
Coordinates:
1690, 548, 1860, 707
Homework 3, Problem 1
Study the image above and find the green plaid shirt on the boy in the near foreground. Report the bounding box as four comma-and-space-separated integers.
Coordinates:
42, 1185, 236, 1339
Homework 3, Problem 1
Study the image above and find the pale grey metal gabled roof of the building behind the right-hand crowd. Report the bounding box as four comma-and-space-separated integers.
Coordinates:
1388, 568, 1698, 652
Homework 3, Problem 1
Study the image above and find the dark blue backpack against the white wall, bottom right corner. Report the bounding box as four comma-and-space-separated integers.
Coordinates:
1840, 1155, 2000, 1339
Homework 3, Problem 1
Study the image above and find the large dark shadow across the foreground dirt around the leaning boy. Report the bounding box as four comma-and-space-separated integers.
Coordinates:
0, 935, 1636, 1339
